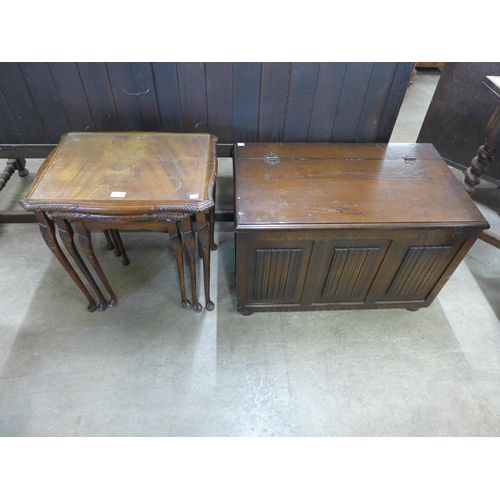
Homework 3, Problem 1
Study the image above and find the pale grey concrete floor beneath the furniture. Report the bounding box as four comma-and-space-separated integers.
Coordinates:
0, 72, 500, 436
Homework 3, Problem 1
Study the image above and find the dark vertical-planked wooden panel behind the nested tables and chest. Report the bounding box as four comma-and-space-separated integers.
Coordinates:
0, 62, 414, 157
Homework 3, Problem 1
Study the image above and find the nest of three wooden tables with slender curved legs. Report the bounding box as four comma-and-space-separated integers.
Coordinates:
20, 132, 217, 312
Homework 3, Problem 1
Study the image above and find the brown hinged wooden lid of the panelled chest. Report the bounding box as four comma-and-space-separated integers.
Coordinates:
235, 143, 488, 230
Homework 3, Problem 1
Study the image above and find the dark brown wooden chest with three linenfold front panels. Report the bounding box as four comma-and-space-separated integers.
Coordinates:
234, 143, 489, 314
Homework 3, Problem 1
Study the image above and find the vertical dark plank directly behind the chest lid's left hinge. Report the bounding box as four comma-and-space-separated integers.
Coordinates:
259, 63, 290, 142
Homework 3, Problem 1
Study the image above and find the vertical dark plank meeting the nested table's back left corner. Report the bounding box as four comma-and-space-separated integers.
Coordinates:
48, 62, 94, 132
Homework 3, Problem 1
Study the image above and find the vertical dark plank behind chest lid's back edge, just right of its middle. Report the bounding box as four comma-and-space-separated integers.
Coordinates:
331, 63, 373, 142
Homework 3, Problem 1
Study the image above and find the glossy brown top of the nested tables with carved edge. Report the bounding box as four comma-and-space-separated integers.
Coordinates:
21, 132, 217, 215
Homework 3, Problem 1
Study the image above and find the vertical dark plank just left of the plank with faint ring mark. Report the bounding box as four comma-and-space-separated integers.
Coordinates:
77, 62, 121, 132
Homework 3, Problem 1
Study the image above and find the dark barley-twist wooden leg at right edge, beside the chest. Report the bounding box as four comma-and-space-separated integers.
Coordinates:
463, 105, 500, 195
